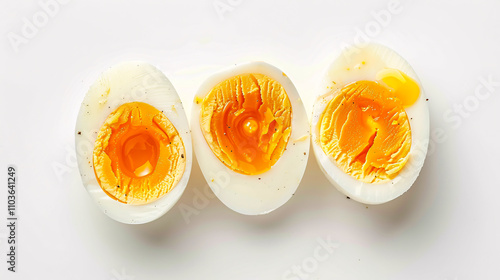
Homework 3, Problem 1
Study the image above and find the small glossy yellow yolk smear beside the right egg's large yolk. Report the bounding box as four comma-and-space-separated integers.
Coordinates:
377, 69, 420, 107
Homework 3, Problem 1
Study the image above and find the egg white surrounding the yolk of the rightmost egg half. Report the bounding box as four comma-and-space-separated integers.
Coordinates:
311, 43, 429, 204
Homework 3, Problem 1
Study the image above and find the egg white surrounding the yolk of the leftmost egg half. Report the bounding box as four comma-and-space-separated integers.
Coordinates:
75, 61, 192, 224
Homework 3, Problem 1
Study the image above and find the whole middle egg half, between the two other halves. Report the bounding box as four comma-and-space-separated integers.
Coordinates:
191, 62, 310, 215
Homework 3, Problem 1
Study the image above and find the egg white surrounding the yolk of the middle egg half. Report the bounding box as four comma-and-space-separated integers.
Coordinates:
191, 62, 310, 215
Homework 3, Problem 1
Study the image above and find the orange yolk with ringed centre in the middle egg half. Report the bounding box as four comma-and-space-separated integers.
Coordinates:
200, 74, 292, 175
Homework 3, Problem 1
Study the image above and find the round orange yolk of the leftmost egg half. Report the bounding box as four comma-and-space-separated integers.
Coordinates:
93, 102, 186, 204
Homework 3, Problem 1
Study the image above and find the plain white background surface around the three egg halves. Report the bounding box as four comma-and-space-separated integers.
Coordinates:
0, 0, 500, 280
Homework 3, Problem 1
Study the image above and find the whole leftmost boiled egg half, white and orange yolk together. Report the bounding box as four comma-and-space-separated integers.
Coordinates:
75, 62, 192, 224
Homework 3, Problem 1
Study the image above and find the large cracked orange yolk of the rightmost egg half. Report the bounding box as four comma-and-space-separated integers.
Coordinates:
319, 81, 411, 183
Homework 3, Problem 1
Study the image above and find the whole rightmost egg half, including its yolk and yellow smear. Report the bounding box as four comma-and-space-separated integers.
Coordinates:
311, 44, 429, 204
